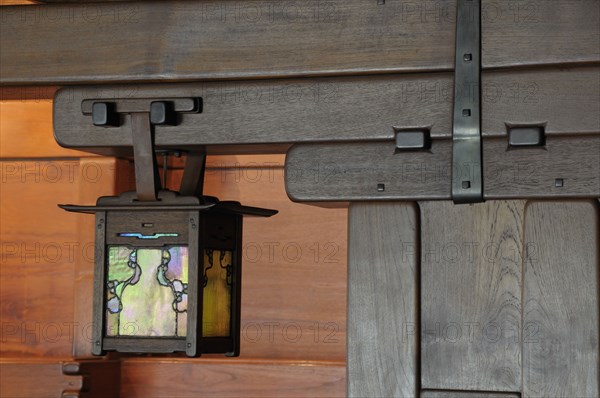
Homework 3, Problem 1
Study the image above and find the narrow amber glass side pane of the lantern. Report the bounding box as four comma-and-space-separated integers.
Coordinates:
202, 249, 234, 337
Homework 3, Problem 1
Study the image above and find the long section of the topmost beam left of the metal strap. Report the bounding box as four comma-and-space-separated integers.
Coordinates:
0, 0, 455, 84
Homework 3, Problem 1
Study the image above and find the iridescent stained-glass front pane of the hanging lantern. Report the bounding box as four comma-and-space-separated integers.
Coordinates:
106, 246, 189, 337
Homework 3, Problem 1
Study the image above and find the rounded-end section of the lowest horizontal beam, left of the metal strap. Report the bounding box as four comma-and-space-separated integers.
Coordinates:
285, 140, 452, 202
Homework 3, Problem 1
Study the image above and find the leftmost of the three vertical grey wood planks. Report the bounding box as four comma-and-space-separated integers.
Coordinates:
347, 203, 418, 397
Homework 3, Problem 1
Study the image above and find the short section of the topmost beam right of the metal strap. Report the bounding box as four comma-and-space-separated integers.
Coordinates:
481, 0, 600, 68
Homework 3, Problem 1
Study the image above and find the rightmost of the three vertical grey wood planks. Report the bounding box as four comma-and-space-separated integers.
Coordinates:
523, 201, 599, 397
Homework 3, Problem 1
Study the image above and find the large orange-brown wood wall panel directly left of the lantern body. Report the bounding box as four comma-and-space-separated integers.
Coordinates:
0, 159, 132, 357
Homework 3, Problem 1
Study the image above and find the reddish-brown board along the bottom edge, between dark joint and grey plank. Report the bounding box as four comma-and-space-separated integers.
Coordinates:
121, 359, 345, 398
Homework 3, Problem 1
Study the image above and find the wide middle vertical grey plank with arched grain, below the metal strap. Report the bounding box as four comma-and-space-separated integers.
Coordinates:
420, 201, 525, 392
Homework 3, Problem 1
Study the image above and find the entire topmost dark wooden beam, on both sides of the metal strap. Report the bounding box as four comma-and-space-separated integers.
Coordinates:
0, 0, 600, 85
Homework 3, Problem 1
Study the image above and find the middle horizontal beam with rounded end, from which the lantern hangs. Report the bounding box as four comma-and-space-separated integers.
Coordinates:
54, 66, 600, 154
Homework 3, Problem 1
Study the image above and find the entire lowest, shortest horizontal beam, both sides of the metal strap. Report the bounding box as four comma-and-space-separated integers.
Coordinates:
285, 134, 600, 203
